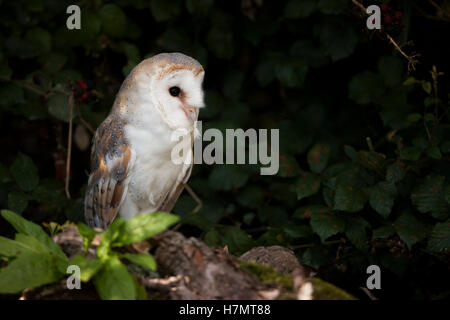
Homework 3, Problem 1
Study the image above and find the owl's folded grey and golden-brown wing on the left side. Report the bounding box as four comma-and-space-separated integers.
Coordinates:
84, 117, 135, 229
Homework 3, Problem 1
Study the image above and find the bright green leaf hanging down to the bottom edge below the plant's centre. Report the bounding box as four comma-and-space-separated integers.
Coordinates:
94, 257, 137, 300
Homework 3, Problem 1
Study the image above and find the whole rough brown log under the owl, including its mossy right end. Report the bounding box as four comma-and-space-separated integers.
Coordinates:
21, 227, 350, 300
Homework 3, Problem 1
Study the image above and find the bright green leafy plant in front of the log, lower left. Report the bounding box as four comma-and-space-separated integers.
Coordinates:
0, 210, 178, 299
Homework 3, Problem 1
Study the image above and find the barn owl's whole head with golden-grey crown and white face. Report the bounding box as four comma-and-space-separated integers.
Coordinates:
121, 53, 205, 129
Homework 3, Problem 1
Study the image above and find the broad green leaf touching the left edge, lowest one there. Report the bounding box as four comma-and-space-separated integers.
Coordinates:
0, 251, 63, 293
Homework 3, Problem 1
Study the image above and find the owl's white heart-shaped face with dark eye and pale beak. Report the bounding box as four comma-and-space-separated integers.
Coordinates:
150, 69, 205, 128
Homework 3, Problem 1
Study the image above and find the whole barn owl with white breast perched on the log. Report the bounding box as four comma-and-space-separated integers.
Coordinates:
84, 53, 205, 229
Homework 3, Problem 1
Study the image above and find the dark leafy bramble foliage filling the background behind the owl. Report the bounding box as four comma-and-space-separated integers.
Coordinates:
0, 0, 450, 299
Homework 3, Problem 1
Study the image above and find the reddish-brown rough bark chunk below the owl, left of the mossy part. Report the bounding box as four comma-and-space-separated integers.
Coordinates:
148, 231, 280, 300
